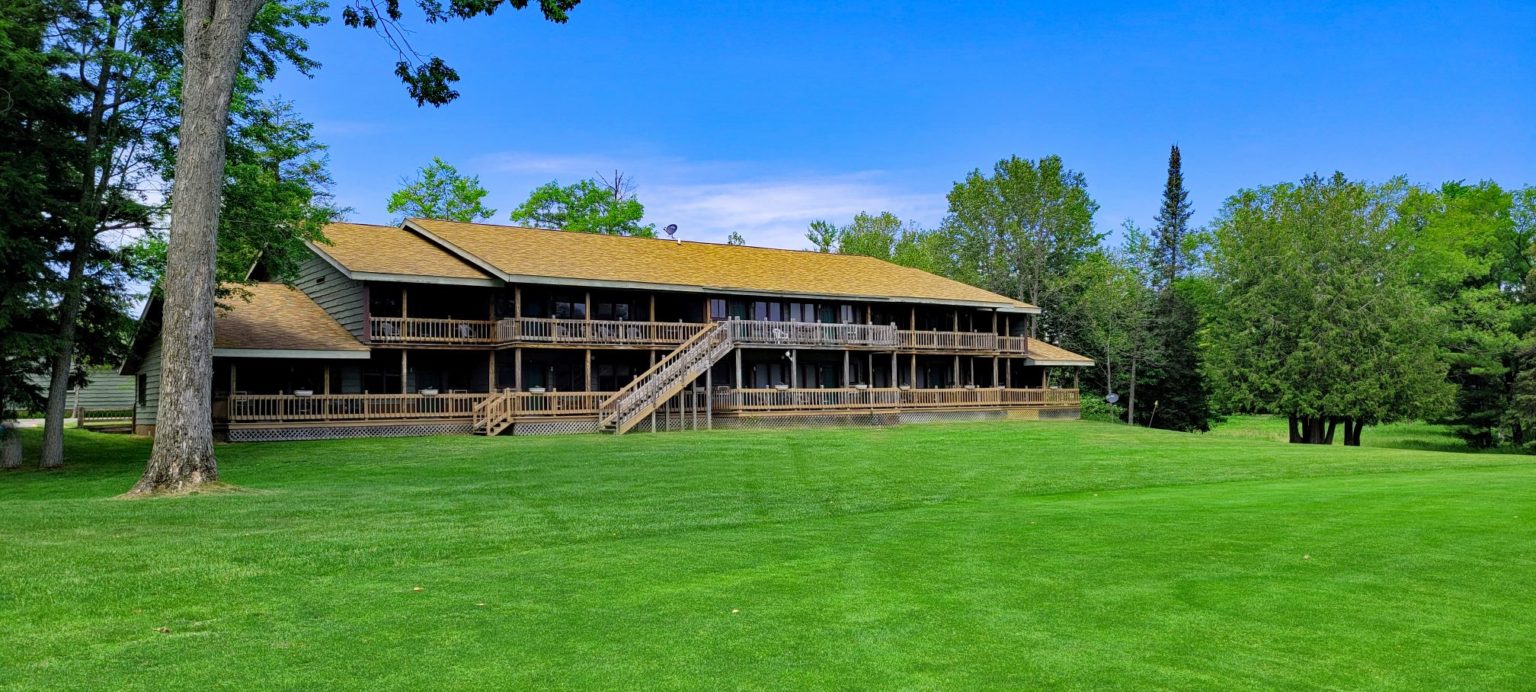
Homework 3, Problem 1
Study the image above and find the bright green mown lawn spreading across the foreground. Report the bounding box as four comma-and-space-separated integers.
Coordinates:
0, 419, 1536, 689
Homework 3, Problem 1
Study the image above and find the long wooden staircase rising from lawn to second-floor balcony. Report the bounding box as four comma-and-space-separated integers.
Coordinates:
598, 322, 736, 434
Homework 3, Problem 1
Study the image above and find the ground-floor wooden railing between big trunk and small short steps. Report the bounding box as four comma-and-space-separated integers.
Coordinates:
229, 393, 490, 423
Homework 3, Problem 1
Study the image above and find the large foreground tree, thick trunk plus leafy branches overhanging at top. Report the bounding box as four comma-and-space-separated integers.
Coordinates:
141, 0, 579, 494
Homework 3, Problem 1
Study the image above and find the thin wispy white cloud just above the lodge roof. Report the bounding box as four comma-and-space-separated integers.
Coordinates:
473, 152, 945, 249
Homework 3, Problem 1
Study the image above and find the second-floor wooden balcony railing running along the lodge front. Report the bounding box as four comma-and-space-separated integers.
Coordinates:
370, 318, 1028, 354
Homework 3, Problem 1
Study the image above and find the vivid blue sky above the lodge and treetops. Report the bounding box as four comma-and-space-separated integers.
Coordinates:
270, 0, 1536, 247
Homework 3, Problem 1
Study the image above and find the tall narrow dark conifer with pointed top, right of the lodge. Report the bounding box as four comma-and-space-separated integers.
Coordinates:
1134, 144, 1213, 431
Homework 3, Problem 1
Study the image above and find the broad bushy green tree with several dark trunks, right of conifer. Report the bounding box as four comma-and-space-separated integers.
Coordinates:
1209, 173, 1453, 445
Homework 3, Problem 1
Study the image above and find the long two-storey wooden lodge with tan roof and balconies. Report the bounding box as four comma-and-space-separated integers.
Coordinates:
123, 219, 1092, 440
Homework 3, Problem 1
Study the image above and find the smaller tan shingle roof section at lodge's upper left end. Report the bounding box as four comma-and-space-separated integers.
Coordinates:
315, 224, 487, 279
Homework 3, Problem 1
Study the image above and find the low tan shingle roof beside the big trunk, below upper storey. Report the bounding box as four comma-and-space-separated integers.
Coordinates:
214, 284, 369, 351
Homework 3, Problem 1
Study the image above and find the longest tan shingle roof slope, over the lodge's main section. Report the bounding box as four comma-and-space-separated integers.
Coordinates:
410, 219, 1029, 308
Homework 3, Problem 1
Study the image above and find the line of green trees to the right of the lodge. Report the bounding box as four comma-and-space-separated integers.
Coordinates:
806, 146, 1536, 447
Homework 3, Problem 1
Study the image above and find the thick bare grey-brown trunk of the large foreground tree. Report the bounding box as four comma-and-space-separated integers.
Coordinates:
132, 0, 264, 494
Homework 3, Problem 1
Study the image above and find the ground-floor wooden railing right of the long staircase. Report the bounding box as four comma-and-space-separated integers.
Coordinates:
714, 388, 1078, 413
